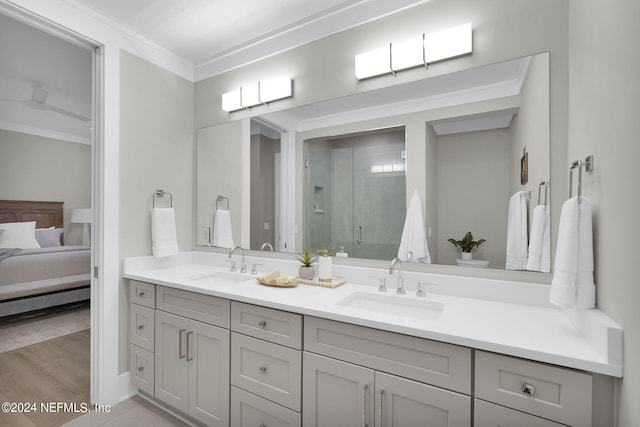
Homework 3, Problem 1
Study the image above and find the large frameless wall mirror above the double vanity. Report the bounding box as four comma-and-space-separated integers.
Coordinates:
196, 53, 550, 269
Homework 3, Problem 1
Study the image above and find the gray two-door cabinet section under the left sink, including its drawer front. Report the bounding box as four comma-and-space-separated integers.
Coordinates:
155, 287, 230, 426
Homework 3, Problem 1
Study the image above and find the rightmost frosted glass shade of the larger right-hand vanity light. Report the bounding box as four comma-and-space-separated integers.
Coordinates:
424, 22, 473, 63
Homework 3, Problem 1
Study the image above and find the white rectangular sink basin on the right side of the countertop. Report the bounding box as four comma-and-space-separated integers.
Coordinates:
338, 292, 444, 320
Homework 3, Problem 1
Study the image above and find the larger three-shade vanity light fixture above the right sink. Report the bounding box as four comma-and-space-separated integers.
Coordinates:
355, 22, 472, 80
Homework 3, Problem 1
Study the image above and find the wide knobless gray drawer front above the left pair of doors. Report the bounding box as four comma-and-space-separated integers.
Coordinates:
156, 286, 231, 329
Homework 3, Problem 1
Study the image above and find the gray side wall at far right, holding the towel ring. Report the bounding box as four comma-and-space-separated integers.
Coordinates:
568, 0, 640, 427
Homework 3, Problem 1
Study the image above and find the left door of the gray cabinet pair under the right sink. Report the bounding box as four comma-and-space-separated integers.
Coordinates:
302, 352, 374, 427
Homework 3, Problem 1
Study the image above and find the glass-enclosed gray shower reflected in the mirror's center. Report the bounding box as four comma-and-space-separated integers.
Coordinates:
304, 127, 406, 259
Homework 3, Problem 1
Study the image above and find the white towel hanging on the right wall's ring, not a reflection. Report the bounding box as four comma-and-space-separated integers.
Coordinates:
549, 197, 596, 309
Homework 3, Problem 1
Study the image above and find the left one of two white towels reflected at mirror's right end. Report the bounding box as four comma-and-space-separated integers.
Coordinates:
505, 191, 528, 270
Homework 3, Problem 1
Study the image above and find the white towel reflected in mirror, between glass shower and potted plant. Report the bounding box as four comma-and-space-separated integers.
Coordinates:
398, 190, 431, 264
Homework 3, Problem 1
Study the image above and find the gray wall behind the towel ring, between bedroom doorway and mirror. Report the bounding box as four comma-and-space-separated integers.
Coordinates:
118, 52, 195, 373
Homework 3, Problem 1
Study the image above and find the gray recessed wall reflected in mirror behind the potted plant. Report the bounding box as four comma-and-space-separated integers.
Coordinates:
434, 129, 511, 268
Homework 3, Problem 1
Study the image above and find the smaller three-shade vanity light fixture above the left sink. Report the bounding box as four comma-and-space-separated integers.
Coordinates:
222, 76, 293, 112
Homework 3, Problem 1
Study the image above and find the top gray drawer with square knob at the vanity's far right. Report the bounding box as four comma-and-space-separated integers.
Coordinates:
475, 351, 592, 426
